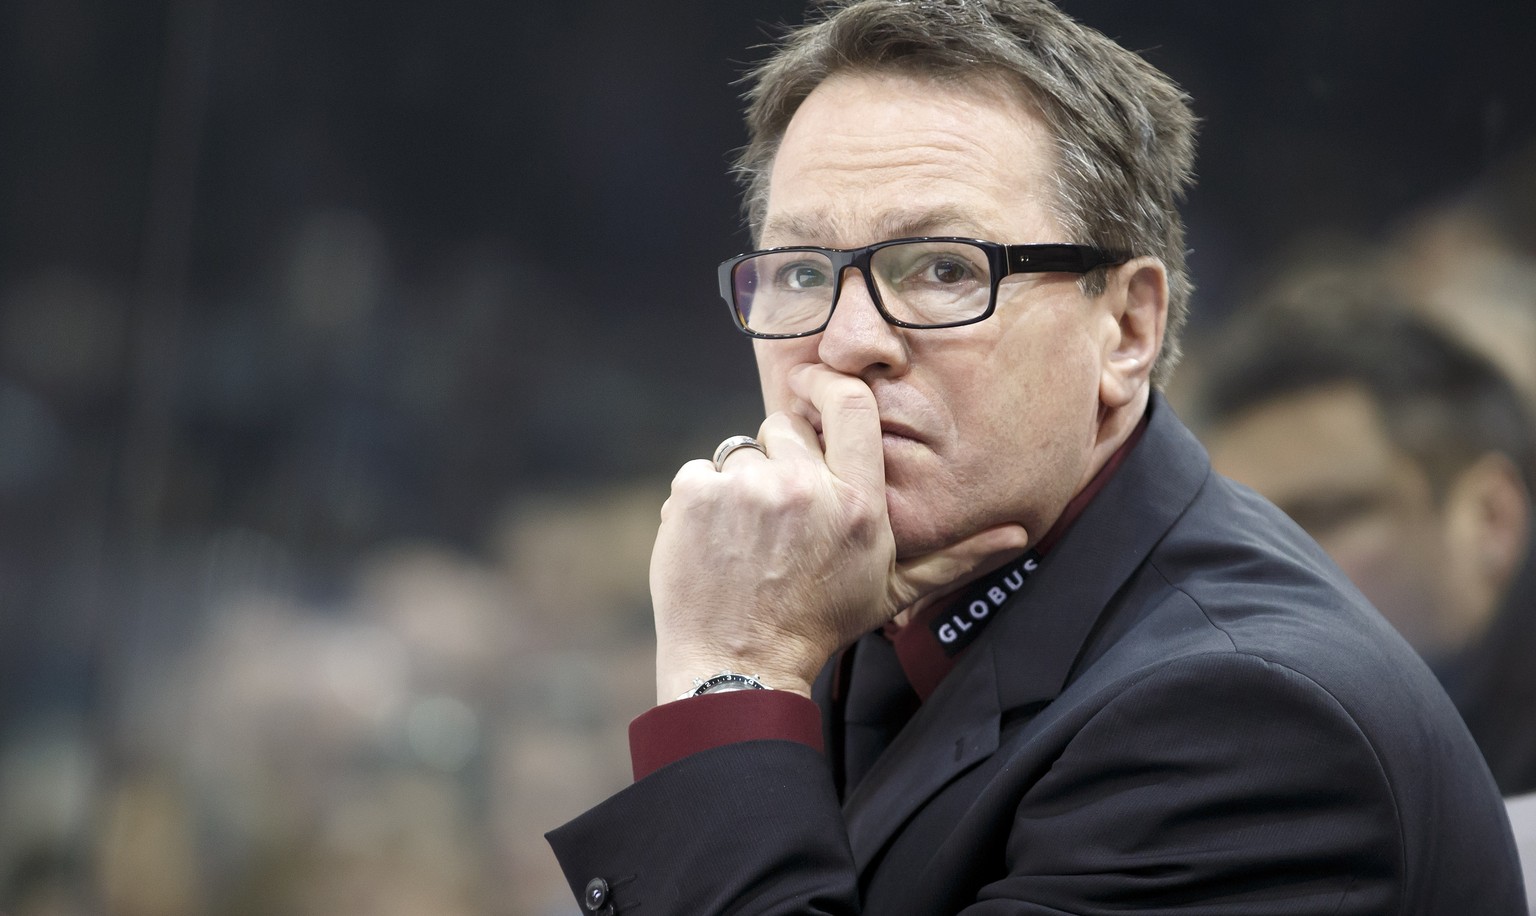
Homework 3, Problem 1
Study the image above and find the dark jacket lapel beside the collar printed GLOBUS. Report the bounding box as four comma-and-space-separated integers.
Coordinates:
843, 395, 1210, 875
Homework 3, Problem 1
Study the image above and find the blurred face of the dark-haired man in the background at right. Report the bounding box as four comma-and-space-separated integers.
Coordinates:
1206, 383, 1471, 658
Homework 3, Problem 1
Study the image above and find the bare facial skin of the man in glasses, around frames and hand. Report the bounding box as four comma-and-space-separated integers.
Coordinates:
756, 74, 1115, 556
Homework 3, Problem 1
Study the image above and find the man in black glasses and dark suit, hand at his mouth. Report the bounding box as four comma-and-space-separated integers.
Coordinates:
550, 0, 1522, 914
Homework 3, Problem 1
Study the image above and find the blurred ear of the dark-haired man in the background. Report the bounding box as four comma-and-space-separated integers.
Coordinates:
1444, 452, 1531, 615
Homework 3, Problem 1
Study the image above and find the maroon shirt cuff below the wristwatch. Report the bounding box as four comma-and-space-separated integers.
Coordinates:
630, 690, 822, 782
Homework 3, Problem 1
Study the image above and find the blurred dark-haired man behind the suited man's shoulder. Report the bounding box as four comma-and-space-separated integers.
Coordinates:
1201, 295, 1536, 795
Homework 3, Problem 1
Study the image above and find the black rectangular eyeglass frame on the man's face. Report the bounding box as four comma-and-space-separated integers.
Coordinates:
719, 235, 1132, 340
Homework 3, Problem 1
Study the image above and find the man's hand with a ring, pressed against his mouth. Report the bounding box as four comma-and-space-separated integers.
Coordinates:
651, 364, 1028, 702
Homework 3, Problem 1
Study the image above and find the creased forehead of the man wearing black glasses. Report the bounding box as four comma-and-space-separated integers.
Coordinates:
762, 72, 1058, 244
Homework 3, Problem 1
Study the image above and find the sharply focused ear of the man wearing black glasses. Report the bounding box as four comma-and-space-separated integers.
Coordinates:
1098, 258, 1167, 407
